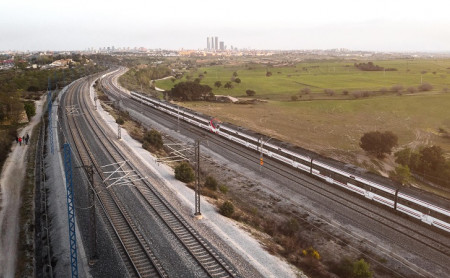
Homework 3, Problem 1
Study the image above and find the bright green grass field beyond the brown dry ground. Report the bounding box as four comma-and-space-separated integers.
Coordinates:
156, 59, 450, 100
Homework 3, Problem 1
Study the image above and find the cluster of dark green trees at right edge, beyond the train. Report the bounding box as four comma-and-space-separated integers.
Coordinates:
395, 146, 450, 186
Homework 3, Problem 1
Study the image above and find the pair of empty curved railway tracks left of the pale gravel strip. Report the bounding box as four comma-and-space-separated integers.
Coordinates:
62, 75, 241, 277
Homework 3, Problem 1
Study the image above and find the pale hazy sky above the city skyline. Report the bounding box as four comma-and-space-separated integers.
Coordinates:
0, 0, 450, 51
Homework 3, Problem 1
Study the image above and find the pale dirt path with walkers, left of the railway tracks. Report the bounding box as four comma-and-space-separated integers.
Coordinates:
0, 97, 45, 278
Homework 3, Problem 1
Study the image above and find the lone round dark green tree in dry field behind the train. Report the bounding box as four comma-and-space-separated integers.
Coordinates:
359, 131, 398, 158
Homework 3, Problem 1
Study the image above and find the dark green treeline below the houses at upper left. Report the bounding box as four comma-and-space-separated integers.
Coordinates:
0, 66, 102, 93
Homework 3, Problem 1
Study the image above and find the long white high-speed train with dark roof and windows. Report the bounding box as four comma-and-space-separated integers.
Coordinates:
131, 92, 450, 232
